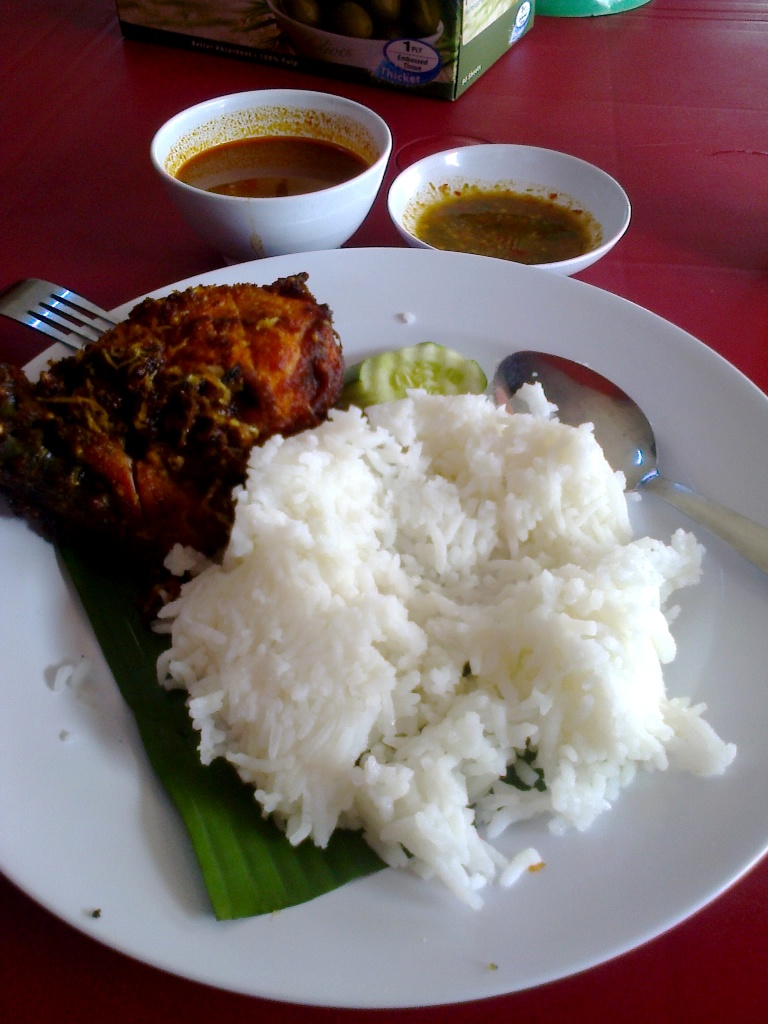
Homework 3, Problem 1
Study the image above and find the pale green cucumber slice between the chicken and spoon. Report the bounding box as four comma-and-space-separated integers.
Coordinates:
341, 341, 487, 408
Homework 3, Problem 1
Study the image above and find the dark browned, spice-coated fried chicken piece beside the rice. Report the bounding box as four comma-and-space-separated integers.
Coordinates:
0, 274, 343, 560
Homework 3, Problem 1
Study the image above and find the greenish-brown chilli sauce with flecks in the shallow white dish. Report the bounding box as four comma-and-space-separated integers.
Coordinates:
412, 185, 600, 264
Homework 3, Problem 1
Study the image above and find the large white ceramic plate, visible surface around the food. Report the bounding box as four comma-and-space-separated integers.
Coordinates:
0, 249, 768, 1008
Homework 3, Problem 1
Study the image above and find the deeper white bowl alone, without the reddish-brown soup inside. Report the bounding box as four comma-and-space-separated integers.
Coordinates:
151, 89, 392, 262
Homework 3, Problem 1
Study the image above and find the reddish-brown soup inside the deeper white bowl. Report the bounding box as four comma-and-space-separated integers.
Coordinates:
176, 135, 369, 199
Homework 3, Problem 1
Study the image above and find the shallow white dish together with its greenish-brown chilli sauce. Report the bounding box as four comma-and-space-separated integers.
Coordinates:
388, 143, 632, 274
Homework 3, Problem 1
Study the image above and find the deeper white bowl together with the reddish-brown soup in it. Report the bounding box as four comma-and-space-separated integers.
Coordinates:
151, 89, 392, 263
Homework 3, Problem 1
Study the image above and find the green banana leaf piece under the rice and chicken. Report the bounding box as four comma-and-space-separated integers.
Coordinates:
58, 545, 384, 921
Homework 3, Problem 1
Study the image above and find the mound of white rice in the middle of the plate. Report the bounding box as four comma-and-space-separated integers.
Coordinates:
159, 387, 735, 905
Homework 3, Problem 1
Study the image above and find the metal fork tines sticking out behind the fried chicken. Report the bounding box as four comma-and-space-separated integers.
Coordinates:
0, 278, 115, 348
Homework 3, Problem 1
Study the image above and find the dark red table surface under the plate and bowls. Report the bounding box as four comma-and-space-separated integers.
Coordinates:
0, 0, 768, 1024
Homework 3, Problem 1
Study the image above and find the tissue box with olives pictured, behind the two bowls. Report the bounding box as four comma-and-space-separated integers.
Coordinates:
117, 0, 535, 99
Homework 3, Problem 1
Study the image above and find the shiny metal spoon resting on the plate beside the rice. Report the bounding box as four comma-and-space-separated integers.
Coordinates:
493, 351, 768, 572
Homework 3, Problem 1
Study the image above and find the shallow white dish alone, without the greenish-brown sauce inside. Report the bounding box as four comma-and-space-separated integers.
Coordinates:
387, 143, 632, 275
